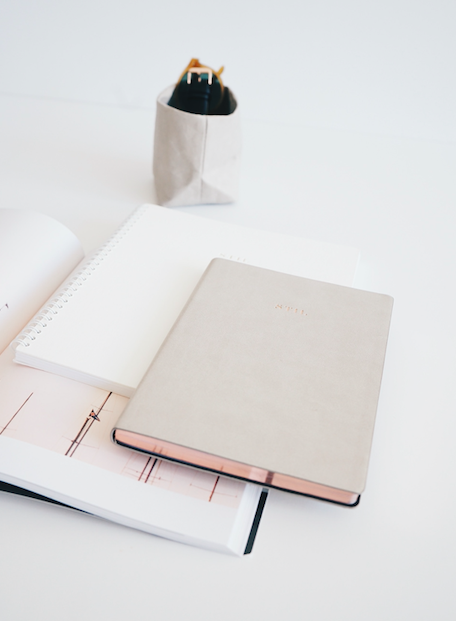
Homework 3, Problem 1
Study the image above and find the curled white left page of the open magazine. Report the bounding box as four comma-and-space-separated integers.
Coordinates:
0, 209, 84, 352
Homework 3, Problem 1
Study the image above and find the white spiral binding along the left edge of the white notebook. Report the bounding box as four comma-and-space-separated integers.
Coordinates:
11, 206, 147, 349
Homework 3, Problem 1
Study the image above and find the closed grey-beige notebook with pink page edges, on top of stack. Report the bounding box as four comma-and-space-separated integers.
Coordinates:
113, 259, 393, 505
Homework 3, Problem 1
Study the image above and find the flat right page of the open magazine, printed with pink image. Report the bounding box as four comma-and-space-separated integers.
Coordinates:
0, 348, 261, 554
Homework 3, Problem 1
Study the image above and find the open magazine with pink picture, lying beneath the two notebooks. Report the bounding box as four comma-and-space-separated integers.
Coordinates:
0, 209, 266, 555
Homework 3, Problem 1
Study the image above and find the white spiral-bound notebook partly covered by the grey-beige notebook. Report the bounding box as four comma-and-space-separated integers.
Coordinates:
13, 205, 358, 397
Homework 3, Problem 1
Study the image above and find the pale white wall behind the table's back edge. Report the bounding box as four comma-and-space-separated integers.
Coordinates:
0, 0, 456, 140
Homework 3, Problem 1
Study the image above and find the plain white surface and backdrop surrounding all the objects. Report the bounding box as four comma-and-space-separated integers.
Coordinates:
0, 0, 456, 621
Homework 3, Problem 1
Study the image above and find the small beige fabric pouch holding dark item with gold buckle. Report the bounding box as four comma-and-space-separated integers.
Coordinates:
153, 59, 241, 207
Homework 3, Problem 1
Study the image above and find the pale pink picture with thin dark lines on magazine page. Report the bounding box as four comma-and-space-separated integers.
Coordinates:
0, 350, 245, 507
